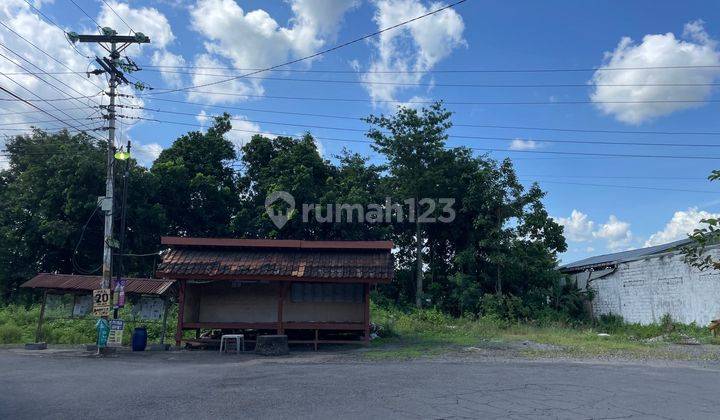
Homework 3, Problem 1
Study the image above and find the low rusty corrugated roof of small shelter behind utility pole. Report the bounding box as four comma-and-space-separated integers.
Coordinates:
20, 273, 175, 295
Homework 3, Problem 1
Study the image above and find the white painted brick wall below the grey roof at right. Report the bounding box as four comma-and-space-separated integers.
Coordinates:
592, 249, 720, 326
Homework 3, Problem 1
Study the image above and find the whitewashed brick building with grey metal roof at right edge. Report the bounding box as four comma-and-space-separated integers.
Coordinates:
561, 240, 720, 326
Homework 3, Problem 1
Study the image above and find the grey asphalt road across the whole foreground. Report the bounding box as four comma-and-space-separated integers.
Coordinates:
0, 350, 720, 419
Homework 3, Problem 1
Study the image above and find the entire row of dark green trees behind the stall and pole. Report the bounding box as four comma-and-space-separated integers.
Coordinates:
0, 103, 566, 314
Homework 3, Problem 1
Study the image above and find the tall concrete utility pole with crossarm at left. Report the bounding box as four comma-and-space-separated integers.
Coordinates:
68, 28, 150, 289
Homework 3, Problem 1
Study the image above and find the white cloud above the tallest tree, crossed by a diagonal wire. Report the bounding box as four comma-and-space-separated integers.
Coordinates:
361, 0, 466, 101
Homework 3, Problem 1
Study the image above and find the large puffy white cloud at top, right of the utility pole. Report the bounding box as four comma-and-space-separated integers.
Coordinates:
190, 0, 358, 102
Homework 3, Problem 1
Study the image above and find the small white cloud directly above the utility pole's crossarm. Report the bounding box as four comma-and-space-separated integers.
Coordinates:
97, 1, 175, 49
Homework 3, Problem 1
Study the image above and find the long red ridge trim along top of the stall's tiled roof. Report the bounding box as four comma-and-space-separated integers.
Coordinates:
160, 236, 393, 250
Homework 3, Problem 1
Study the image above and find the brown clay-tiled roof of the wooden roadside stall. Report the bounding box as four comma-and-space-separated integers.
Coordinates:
156, 240, 393, 283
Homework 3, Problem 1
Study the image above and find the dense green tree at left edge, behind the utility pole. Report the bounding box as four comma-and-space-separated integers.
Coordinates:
0, 130, 164, 300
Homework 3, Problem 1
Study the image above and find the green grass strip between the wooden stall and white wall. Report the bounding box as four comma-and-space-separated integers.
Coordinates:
365, 305, 720, 359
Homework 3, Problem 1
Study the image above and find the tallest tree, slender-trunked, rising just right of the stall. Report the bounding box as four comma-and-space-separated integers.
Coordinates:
365, 102, 452, 307
